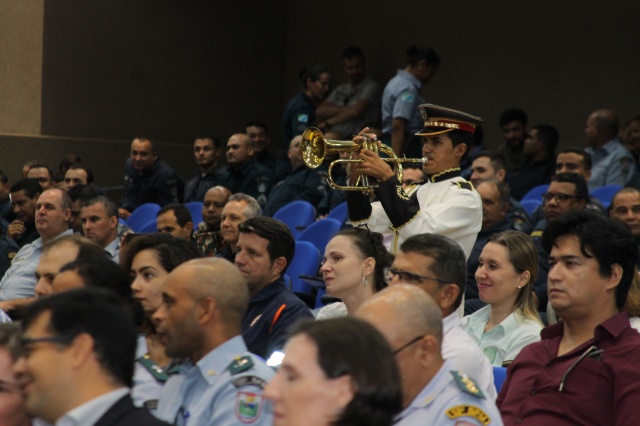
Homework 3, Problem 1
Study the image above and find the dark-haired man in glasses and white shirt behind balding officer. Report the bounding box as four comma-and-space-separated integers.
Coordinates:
385, 234, 496, 401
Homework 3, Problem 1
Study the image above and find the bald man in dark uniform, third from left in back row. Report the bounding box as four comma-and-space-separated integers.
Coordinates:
220, 133, 273, 208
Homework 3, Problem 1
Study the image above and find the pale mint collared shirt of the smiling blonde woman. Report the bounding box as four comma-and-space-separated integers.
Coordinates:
462, 305, 542, 367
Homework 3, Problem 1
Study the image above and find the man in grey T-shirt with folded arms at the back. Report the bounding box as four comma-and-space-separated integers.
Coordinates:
316, 46, 382, 138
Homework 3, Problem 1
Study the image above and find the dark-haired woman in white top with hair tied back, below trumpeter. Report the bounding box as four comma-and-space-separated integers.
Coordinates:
318, 228, 393, 318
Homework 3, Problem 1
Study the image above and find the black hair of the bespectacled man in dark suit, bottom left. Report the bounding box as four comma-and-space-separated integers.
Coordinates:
23, 288, 137, 387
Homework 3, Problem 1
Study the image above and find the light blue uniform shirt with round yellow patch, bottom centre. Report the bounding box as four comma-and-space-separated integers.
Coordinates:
394, 361, 502, 426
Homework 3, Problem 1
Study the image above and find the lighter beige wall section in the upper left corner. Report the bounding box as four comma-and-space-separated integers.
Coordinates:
0, 0, 44, 135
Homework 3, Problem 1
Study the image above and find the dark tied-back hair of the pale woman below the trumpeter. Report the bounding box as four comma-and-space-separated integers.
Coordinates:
333, 228, 393, 292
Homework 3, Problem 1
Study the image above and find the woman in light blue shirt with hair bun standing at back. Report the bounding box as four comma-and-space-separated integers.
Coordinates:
380, 46, 440, 158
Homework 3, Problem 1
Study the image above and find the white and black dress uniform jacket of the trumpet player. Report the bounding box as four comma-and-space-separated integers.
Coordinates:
346, 168, 482, 258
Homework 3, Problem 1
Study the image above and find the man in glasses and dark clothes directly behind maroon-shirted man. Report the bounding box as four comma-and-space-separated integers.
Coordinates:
531, 173, 589, 312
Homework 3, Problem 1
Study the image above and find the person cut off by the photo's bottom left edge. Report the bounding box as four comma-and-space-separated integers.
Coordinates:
0, 324, 31, 426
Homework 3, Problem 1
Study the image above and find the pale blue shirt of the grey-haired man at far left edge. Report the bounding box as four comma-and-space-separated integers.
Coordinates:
0, 229, 73, 301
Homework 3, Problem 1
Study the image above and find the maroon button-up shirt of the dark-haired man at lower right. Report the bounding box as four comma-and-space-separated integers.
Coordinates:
496, 312, 640, 426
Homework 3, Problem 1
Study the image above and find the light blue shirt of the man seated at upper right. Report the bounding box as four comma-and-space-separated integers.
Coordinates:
585, 138, 636, 191
